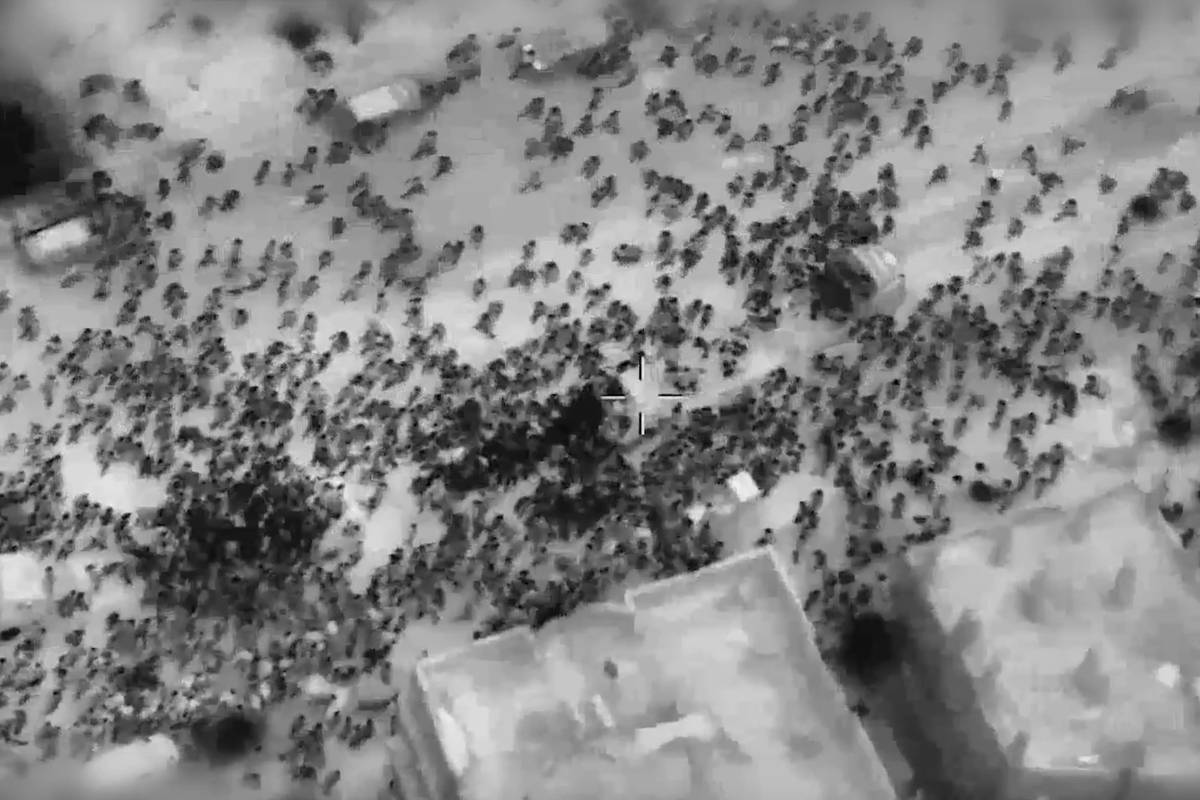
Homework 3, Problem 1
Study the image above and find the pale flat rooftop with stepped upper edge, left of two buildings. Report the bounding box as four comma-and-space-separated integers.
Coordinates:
416, 548, 894, 800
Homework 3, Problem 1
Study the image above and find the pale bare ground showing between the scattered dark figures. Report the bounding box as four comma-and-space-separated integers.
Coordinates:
0, 4, 1200, 790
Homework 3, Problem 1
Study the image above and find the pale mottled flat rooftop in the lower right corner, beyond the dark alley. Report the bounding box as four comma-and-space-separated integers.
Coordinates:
898, 485, 1200, 796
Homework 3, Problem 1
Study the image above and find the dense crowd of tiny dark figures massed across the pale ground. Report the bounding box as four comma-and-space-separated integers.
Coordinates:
0, 3, 1200, 793
